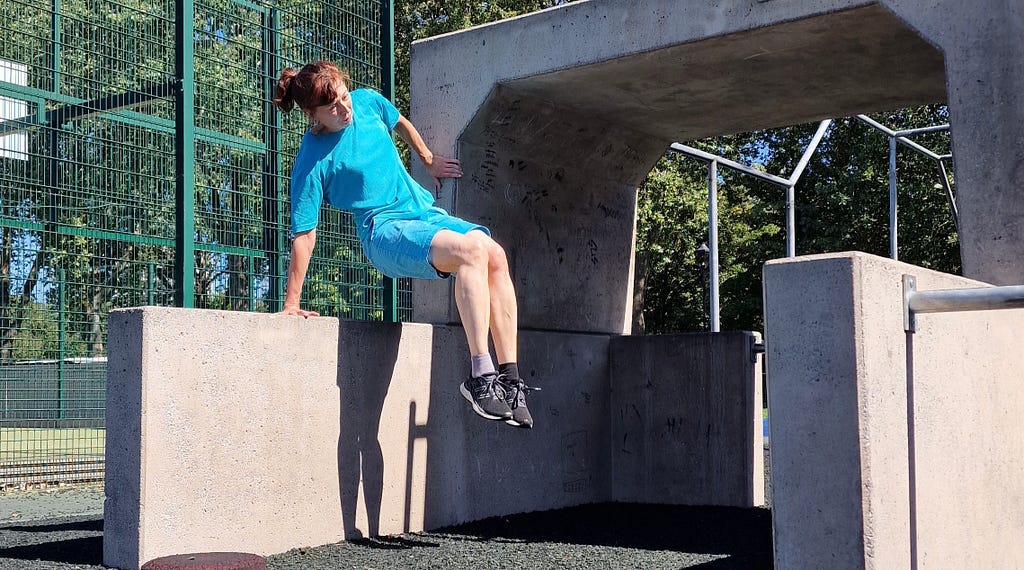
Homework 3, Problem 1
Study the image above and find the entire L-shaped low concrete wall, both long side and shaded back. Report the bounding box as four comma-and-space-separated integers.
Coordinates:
103, 307, 764, 570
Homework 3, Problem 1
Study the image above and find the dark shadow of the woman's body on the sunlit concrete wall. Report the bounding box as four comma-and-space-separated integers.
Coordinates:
338, 320, 401, 539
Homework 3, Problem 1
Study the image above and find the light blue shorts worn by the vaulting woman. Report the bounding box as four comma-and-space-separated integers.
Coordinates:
362, 208, 490, 279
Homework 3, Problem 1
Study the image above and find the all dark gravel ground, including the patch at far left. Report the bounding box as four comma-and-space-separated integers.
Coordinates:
0, 452, 772, 570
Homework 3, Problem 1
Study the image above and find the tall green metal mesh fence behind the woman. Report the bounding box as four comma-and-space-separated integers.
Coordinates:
0, 0, 399, 487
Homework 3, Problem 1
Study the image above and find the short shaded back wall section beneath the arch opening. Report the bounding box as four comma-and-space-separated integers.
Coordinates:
610, 332, 764, 507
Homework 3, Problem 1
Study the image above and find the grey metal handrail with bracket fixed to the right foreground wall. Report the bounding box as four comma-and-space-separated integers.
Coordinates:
903, 275, 1024, 333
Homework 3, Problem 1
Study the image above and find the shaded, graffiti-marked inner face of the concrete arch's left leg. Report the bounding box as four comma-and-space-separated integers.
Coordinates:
450, 88, 664, 334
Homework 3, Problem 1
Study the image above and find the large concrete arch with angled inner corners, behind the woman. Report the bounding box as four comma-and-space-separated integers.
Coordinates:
411, 0, 1024, 333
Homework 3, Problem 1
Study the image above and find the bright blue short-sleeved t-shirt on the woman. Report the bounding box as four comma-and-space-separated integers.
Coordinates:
291, 89, 434, 242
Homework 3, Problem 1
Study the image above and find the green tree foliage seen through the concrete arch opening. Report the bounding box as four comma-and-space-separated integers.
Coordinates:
634, 105, 961, 333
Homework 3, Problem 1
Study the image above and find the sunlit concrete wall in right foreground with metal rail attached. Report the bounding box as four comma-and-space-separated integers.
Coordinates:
765, 253, 1024, 569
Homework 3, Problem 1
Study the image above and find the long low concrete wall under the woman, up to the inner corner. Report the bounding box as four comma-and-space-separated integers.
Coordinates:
103, 307, 610, 569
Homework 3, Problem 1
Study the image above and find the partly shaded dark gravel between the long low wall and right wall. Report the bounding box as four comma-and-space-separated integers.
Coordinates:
276, 503, 772, 570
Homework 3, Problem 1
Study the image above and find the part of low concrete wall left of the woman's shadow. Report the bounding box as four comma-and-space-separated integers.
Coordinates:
103, 307, 343, 569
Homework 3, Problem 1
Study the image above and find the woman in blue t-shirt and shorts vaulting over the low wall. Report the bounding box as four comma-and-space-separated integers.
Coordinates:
273, 61, 534, 428
